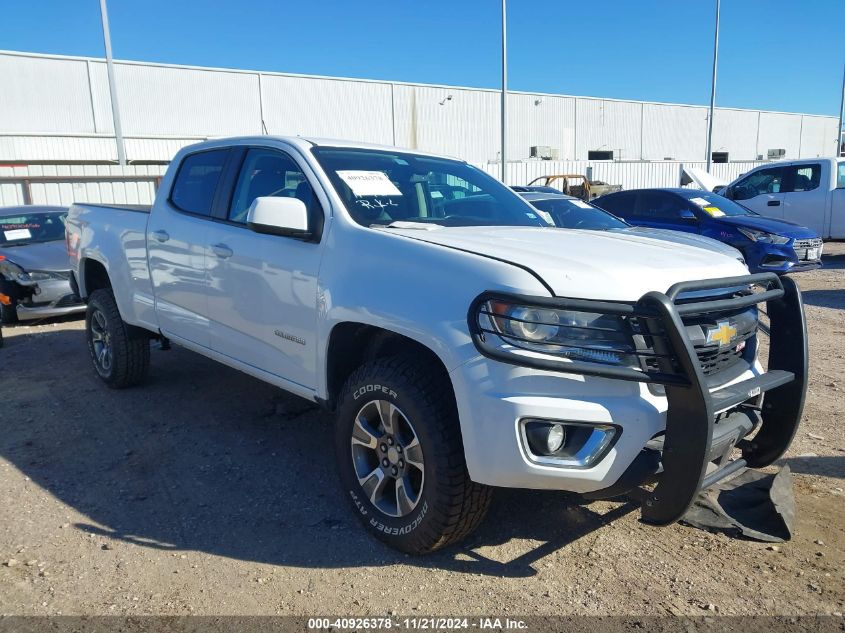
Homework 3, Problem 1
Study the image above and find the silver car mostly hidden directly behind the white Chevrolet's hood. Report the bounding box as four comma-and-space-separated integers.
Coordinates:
518, 191, 745, 264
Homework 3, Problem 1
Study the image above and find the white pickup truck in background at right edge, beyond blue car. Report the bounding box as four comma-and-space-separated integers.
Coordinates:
718, 158, 845, 240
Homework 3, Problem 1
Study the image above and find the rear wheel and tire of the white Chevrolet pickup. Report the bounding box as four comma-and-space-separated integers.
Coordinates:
85, 289, 150, 389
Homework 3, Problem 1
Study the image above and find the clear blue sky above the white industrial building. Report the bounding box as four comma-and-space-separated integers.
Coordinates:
0, 0, 845, 115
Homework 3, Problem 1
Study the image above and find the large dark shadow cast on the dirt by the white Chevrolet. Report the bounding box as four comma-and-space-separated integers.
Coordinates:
0, 329, 635, 577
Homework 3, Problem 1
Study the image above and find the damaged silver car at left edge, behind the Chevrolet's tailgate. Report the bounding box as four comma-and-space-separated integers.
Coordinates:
0, 206, 85, 324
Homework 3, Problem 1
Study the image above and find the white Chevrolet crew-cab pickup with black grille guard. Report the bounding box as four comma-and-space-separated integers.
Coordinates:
67, 137, 807, 553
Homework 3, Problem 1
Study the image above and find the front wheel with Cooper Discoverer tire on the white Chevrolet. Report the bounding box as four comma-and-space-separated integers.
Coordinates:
335, 357, 492, 554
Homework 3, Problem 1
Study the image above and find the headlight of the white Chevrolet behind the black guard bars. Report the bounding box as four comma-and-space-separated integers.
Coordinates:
478, 299, 637, 367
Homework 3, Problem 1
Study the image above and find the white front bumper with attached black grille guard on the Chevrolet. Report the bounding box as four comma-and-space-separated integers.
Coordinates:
452, 273, 807, 524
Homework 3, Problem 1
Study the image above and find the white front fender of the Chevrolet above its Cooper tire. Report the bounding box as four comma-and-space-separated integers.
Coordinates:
317, 227, 548, 398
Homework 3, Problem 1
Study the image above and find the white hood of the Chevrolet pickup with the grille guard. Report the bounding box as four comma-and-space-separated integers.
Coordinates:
381, 226, 748, 301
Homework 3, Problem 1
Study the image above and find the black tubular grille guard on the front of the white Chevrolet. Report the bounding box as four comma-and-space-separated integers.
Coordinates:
469, 273, 808, 525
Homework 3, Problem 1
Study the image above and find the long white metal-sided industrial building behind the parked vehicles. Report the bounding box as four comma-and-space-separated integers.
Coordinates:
0, 51, 838, 203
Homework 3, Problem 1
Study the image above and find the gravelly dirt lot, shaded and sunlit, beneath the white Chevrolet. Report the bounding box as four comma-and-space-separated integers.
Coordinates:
0, 244, 845, 615
